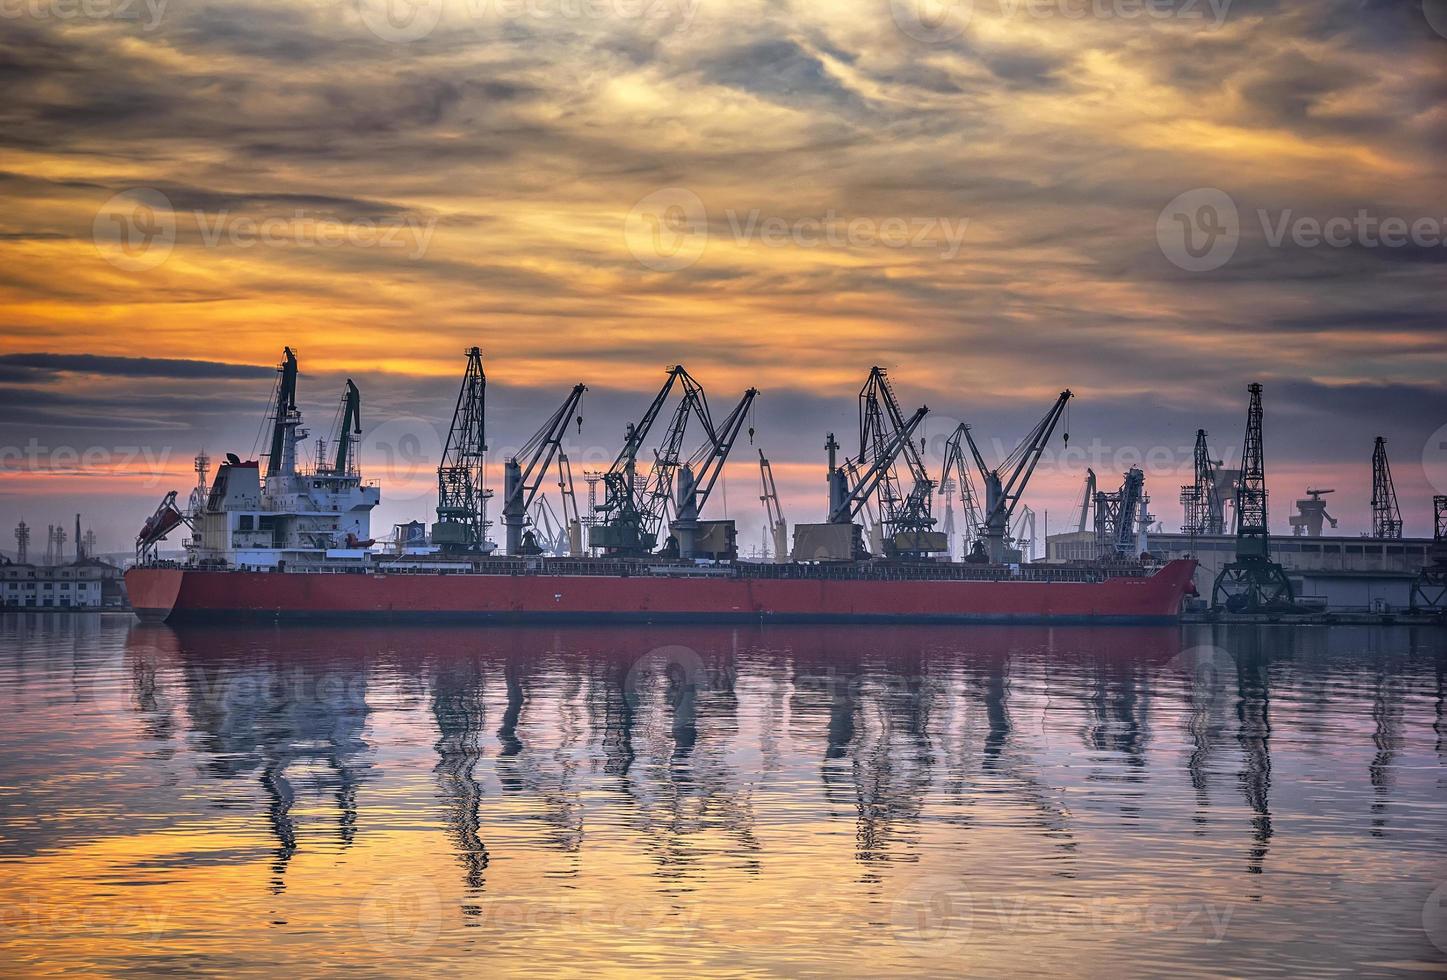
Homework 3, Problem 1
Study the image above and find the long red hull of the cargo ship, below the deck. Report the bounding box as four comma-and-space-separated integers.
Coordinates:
126, 560, 1195, 624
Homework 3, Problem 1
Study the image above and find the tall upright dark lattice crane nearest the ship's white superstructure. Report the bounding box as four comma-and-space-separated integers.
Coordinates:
433, 347, 491, 552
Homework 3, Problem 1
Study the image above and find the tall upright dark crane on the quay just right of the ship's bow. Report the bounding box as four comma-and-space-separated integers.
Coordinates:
1211, 382, 1295, 612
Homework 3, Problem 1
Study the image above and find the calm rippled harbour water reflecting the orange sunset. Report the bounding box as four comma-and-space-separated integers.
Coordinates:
0, 615, 1447, 976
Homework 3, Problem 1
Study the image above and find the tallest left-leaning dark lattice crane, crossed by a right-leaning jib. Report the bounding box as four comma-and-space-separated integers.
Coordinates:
857, 366, 949, 559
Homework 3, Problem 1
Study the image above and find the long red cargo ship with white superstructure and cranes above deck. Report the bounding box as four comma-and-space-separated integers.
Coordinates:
126, 347, 1195, 624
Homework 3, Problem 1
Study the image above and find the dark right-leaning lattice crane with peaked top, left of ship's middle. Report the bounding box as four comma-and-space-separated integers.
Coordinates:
587, 365, 713, 554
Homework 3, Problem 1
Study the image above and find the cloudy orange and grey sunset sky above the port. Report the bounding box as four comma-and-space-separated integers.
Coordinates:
0, 0, 1447, 549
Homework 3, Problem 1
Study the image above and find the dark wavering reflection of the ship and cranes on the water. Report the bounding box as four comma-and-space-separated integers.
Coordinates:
87, 616, 1444, 966
